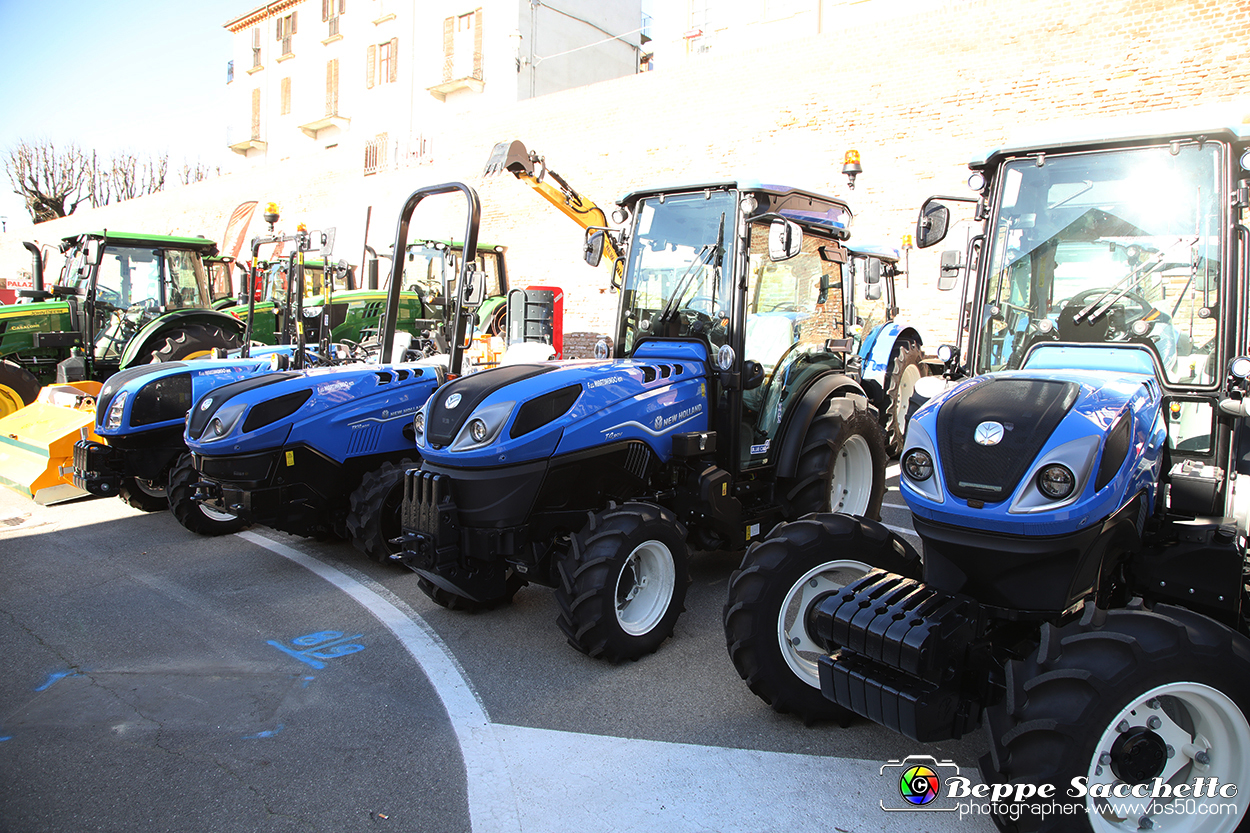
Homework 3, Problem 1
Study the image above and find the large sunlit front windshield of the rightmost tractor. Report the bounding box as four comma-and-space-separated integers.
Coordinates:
976, 143, 1223, 385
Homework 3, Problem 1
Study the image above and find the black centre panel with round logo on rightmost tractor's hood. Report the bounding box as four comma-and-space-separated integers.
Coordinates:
938, 379, 1080, 503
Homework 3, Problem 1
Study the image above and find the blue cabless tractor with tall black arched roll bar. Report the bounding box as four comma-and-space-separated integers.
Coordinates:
185, 183, 486, 562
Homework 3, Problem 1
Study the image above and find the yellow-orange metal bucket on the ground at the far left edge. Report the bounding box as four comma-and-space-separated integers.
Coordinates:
0, 381, 101, 505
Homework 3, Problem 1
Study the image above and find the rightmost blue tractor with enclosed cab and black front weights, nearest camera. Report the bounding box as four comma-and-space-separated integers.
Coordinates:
726, 114, 1250, 833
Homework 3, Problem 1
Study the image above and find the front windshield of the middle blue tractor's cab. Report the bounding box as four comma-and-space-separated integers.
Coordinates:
620, 191, 738, 355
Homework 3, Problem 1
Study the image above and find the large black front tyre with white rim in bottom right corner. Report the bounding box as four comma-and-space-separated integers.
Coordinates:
981, 602, 1250, 833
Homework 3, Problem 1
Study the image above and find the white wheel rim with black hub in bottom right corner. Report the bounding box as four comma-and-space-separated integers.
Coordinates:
1085, 683, 1250, 833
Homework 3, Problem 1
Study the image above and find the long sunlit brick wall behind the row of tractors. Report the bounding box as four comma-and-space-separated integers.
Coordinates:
12, 0, 1250, 355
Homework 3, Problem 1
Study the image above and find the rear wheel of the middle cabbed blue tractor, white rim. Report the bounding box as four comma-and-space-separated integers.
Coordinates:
778, 394, 886, 519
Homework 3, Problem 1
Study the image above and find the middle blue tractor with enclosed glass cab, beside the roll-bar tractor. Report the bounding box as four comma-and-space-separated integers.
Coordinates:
403, 181, 886, 662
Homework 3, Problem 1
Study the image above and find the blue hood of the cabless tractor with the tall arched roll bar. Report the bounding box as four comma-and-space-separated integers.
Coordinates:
186, 364, 443, 460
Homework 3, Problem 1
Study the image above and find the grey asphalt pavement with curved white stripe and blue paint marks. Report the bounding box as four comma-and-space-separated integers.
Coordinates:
0, 469, 993, 833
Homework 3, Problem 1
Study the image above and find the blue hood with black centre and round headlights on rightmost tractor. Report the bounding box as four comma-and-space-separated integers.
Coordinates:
900, 369, 1168, 535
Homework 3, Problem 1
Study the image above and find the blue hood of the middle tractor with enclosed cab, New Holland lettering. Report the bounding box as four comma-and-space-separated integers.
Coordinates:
414, 341, 709, 468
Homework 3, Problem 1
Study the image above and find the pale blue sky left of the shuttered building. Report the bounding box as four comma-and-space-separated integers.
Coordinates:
0, 0, 246, 231
